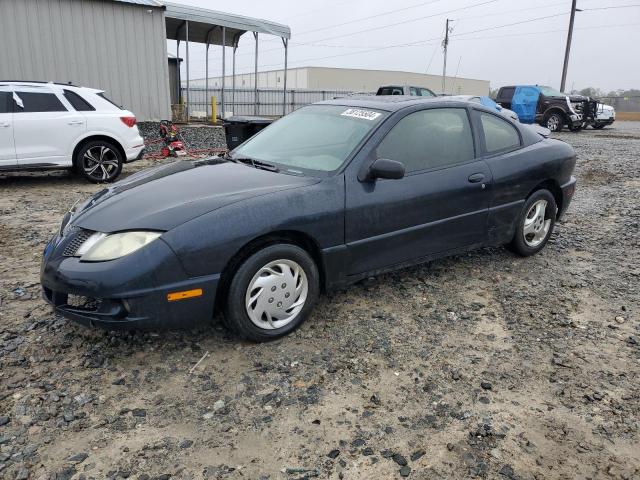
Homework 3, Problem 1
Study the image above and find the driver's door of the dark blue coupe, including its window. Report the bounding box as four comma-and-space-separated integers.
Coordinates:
345, 107, 492, 275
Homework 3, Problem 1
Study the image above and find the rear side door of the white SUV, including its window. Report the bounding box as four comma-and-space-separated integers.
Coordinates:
13, 87, 86, 166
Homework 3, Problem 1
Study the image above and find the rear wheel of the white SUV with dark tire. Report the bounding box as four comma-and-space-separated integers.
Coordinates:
74, 140, 124, 183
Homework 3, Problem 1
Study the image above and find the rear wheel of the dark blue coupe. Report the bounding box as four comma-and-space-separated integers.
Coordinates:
507, 189, 558, 257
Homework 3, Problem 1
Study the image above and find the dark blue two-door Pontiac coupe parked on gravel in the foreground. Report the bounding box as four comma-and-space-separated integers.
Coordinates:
41, 96, 576, 341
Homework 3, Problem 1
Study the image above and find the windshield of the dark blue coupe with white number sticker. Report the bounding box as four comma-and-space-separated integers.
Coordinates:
231, 105, 385, 173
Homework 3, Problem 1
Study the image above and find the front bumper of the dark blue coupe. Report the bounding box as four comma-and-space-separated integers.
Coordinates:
40, 232, 220, 330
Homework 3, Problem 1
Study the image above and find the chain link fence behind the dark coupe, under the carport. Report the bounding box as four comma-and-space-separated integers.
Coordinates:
182, 87, 375, 120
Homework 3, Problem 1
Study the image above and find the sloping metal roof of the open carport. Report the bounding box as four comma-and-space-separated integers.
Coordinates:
163, 1, 291, 41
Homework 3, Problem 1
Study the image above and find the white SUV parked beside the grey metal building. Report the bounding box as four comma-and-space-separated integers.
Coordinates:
0, 81, 144, 183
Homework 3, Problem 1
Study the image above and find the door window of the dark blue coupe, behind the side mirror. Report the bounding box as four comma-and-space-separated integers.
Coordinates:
377, 108, 475, 173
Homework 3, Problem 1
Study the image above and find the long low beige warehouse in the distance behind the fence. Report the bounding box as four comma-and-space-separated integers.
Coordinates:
190, 67, 489, 95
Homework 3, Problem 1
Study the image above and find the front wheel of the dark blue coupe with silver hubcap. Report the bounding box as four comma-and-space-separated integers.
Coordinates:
223, 243, 320, 342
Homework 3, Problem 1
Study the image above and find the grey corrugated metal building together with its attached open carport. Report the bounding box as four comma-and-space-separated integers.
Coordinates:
0, 0, 291, 120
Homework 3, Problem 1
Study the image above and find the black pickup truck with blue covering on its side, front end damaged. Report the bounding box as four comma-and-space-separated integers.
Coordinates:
496, 85, 598, 132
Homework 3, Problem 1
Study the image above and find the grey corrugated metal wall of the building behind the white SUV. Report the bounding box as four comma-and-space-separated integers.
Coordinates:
0, 0, 171, 120
